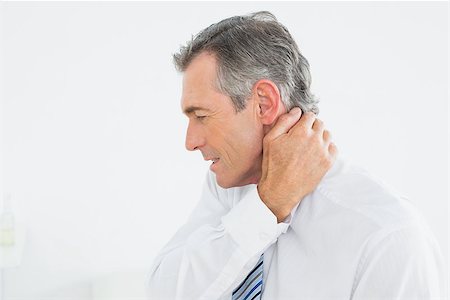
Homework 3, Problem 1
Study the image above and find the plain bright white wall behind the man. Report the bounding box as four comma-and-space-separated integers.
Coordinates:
0, 2, 448, 300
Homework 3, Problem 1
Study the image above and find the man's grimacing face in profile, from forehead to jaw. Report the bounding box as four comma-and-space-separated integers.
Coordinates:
181, 52, 264, 188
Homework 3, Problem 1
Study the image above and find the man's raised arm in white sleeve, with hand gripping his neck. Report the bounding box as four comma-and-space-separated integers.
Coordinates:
150, 109, 336, 300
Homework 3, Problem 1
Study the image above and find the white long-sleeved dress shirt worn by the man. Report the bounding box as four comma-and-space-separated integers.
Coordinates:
150, 160, 446, 300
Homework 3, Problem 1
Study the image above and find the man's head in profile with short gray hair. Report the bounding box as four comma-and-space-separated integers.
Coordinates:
174, 12, 326, 188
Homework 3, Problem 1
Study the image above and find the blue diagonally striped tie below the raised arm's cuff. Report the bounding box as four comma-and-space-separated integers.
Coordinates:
231, 253, 264, 300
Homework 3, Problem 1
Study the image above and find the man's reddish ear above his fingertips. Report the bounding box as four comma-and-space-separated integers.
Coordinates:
253, 79, 284, 125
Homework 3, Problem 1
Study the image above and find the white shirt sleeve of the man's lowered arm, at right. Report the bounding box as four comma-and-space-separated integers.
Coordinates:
352, 226, 446, 300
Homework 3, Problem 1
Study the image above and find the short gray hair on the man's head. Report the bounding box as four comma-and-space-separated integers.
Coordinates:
173, 11, 319, 114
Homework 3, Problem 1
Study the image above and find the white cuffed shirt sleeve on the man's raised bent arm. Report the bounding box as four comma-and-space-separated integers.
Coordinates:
149, 172, 289, 300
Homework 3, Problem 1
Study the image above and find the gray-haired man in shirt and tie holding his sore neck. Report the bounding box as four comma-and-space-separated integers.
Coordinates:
150, 12, 444, 300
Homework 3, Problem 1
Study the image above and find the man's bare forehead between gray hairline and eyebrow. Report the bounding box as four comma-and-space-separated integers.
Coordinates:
181, 53, 220, 113
